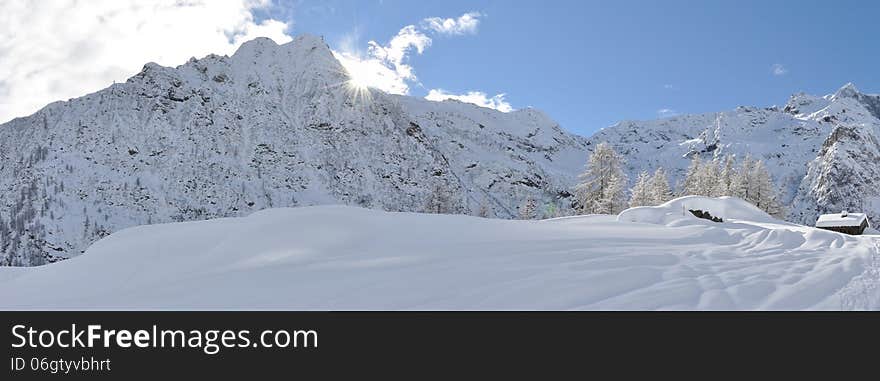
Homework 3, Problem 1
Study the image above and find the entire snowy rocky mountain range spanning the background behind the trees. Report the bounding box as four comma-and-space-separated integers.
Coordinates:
0, 35, 880, 266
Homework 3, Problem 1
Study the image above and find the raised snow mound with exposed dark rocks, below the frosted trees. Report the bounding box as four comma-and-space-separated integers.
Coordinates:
617, 196, 784, 225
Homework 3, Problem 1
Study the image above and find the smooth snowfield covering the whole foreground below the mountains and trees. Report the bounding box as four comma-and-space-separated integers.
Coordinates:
0, 197, 880, 310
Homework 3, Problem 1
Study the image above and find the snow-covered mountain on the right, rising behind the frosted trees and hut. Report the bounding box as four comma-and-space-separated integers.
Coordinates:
588, 84, 880, 226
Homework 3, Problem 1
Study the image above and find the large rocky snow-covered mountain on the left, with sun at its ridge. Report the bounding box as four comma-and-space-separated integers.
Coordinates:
0, 35, 586, 266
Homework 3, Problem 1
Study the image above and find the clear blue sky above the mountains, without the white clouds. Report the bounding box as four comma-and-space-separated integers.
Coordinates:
258, 0, 880, 134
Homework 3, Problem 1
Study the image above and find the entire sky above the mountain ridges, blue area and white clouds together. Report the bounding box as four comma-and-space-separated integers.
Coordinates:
0, 0, 880, 135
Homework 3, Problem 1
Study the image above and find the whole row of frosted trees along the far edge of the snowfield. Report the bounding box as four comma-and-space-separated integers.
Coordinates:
423, 143, 785, 220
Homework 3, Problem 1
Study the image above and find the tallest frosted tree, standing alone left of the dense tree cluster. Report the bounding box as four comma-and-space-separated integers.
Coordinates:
574, 143, 626, 214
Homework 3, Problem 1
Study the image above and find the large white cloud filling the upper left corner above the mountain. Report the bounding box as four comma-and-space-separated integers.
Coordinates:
0, 0, 291, 123
